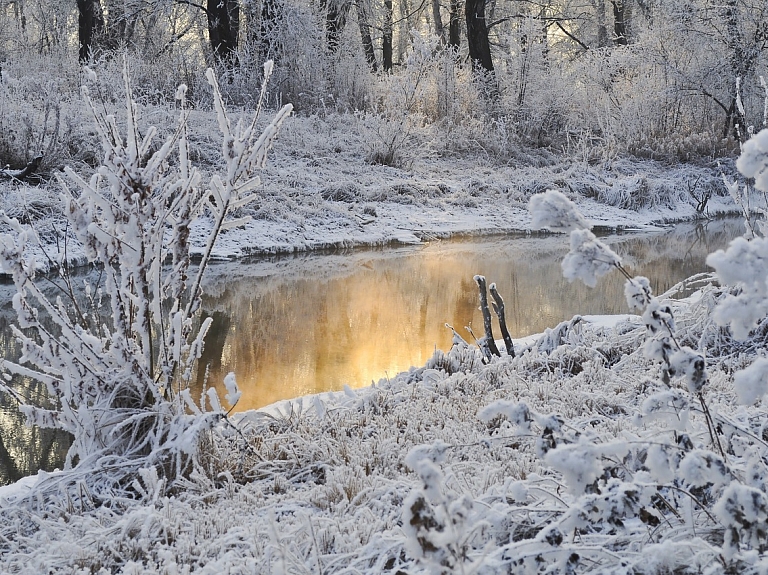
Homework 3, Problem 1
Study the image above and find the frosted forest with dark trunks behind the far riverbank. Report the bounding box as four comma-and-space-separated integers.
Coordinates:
0, 0, 768, 176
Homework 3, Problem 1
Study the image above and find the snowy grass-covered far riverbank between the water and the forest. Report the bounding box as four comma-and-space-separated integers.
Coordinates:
0, 110, 737, 268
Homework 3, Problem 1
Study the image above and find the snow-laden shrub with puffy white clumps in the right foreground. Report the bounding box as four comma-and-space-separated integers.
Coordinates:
420, 174, 768, 573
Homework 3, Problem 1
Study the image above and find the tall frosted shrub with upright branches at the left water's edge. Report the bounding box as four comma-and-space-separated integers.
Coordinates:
0, 62, 291, 498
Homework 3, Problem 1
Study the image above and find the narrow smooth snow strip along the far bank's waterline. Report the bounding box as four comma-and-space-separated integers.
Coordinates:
12, 192, 740, 275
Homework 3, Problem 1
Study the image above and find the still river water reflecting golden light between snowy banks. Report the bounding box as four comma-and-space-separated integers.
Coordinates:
0, 219, 743, 484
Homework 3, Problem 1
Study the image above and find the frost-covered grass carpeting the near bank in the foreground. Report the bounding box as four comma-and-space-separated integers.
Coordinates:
0, 287, 766, 574
